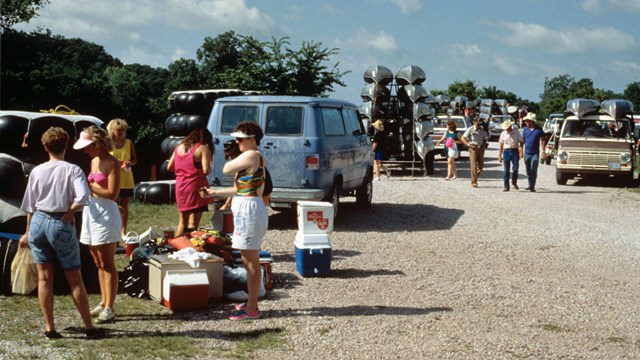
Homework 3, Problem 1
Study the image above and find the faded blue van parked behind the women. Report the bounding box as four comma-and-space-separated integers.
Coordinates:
207, 95, 373, 217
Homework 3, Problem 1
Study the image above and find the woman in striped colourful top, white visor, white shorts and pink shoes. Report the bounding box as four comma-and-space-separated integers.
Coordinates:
200, 122, 269, 320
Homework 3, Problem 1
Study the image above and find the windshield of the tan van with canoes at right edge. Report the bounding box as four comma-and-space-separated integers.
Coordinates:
562, 119, 631, 140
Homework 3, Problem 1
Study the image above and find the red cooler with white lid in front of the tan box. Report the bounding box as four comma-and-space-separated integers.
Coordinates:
162, 269, 209, 311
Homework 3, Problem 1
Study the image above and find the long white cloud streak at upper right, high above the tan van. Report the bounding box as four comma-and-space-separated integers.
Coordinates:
503, 22, 635, 54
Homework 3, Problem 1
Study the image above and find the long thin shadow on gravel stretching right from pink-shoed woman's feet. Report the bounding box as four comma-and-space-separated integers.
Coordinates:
263, 305, 453, 318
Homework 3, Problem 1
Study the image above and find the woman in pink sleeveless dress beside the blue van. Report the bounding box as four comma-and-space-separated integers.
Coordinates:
168, 129, 213, 236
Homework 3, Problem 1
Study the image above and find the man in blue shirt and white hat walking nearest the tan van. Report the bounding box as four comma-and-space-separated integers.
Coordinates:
522, 112, 547, 192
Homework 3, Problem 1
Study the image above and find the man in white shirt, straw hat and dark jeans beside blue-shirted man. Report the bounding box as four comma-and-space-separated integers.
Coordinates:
498, 120, 524, 191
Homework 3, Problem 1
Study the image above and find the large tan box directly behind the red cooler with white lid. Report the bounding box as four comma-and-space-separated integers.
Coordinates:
149, 254, 224, 303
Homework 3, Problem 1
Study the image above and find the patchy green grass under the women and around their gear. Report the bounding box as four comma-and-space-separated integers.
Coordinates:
0, 203, 287, 359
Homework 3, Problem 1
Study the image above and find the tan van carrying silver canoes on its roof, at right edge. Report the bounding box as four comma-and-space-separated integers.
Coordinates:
556, 99, 638, 187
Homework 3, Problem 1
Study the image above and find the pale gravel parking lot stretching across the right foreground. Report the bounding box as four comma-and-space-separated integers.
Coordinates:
255, 142, 640, 359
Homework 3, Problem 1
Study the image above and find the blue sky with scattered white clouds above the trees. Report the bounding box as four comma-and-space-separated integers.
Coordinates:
17, 0, 640, 106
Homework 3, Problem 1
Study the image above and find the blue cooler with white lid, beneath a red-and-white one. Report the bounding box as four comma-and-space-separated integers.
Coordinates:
294, 231, 331, 276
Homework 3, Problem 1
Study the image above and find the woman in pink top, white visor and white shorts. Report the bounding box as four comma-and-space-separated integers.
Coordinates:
73, 126, 122, 322
